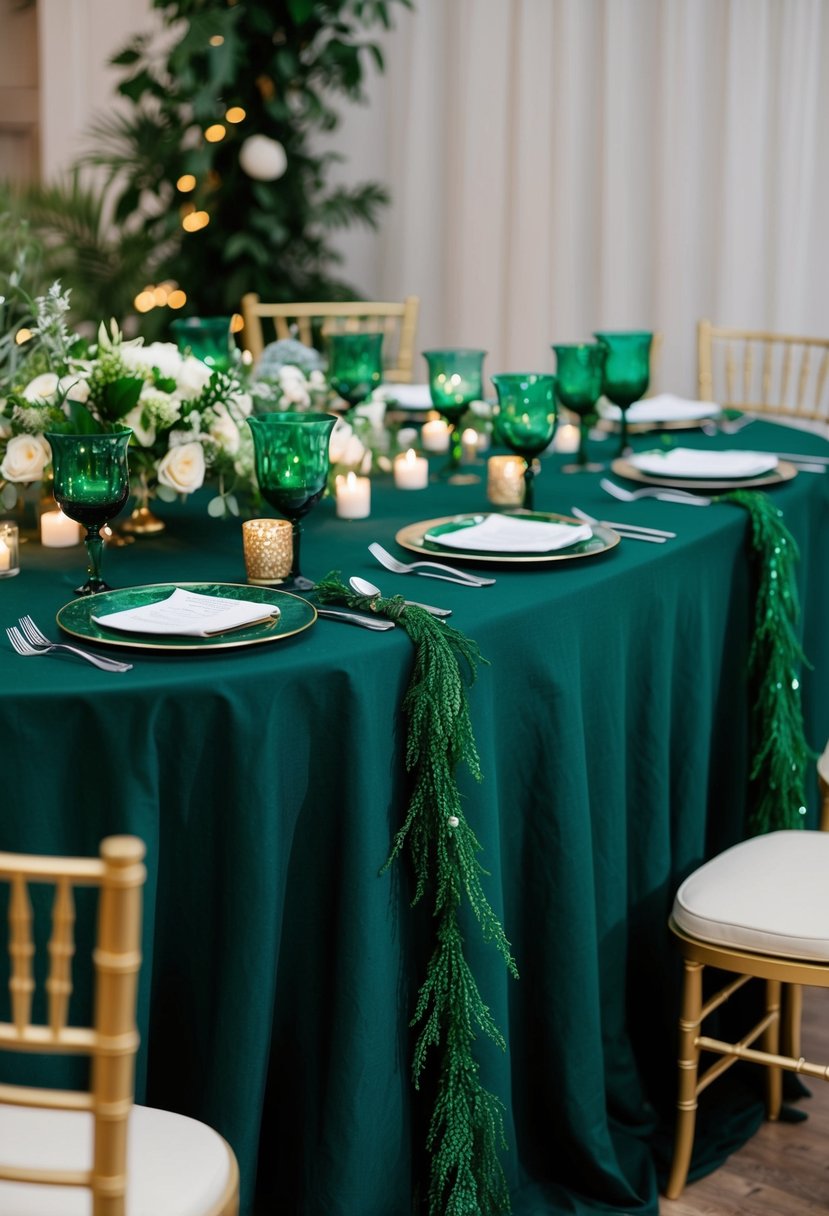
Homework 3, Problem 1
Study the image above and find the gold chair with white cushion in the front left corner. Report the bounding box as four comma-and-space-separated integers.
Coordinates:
0, 837, 238, 1216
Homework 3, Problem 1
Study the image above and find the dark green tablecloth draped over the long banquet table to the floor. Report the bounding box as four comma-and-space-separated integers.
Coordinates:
0, 422, 829, 1216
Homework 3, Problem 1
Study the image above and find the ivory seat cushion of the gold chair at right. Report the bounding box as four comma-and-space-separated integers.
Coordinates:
673, 832, 829, 963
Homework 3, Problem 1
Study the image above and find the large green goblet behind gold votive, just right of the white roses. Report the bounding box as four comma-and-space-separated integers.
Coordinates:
247, 412, 337, 591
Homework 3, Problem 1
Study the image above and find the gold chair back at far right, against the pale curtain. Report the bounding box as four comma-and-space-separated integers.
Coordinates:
697, 321, 829, 423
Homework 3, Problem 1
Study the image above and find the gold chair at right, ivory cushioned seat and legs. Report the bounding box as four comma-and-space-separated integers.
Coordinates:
666, 832, 829, 1199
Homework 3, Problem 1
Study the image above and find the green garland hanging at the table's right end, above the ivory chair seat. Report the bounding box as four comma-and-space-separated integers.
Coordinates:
716, 490, 812, 834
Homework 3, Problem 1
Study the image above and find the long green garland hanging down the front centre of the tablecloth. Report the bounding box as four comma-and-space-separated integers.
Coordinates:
316, 573, 518, 1216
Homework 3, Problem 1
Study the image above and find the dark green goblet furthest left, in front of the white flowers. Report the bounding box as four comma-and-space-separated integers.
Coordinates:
46, 429, 132, 596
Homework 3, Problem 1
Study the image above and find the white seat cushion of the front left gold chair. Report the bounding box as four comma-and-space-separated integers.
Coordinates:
0, 1105, 231, 1216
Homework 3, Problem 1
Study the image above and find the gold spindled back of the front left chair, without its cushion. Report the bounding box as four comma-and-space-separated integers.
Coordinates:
0, 837, 146, 1216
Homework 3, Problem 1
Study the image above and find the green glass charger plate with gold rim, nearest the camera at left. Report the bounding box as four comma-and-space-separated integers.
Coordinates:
55, 582, 317, 652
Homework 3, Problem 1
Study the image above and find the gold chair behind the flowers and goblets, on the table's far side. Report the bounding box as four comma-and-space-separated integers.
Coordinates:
242, 292, 421, 384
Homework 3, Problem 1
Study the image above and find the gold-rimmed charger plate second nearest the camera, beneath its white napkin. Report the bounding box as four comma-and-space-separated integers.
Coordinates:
395, 511, 621, 565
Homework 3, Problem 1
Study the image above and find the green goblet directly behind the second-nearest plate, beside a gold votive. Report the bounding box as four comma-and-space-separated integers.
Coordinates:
492, 372, 557, 511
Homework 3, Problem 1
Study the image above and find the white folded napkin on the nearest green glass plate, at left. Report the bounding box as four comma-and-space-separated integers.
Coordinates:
92, 587, 280, 637
